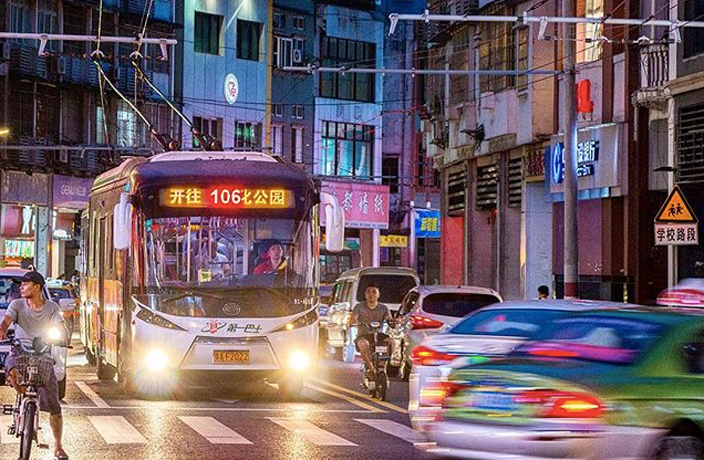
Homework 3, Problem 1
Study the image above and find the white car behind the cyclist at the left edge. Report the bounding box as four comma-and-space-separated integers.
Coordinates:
0, 268, 68, 399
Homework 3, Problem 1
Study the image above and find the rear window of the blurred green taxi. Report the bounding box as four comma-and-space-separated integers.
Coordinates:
516, 315, 662, 364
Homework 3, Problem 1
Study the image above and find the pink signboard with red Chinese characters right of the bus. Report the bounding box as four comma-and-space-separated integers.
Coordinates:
321, 181, 389, 229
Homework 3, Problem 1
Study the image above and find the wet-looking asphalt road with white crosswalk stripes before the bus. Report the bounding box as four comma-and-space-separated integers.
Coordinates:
0, 346, 430, 460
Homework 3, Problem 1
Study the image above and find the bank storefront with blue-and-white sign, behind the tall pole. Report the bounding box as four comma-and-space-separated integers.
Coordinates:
548, 123, 629, 300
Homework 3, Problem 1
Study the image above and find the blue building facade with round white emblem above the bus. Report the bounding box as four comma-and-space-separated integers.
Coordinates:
175, 0, 271, 150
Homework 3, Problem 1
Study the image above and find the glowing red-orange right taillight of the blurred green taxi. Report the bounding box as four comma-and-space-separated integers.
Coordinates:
514, 390, 603, 418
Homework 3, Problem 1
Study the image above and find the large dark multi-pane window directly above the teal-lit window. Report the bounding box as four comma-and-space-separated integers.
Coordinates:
320, 36, 376, 102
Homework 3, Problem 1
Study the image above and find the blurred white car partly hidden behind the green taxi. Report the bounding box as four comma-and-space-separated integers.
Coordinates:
408, 300, 623, 431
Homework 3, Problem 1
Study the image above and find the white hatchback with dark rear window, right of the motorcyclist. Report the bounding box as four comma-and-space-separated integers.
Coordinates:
388, 285, 503, 379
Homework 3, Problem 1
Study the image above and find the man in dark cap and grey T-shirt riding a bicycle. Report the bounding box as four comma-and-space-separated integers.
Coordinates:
0, 271, 68, 460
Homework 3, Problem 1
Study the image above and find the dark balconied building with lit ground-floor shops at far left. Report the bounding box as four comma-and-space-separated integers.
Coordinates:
0, 0, 176, 277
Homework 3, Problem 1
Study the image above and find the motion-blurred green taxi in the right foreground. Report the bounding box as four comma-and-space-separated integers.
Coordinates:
428, 307, 704, 460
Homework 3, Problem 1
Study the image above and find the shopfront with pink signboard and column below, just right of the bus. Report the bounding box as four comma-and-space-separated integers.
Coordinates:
321, 181, 389, 267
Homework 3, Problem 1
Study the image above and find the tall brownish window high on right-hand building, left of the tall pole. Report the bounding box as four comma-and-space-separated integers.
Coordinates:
479, 5, 516, 93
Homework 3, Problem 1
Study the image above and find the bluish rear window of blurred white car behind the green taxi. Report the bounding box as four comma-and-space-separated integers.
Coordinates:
449, 308, 567, 337
